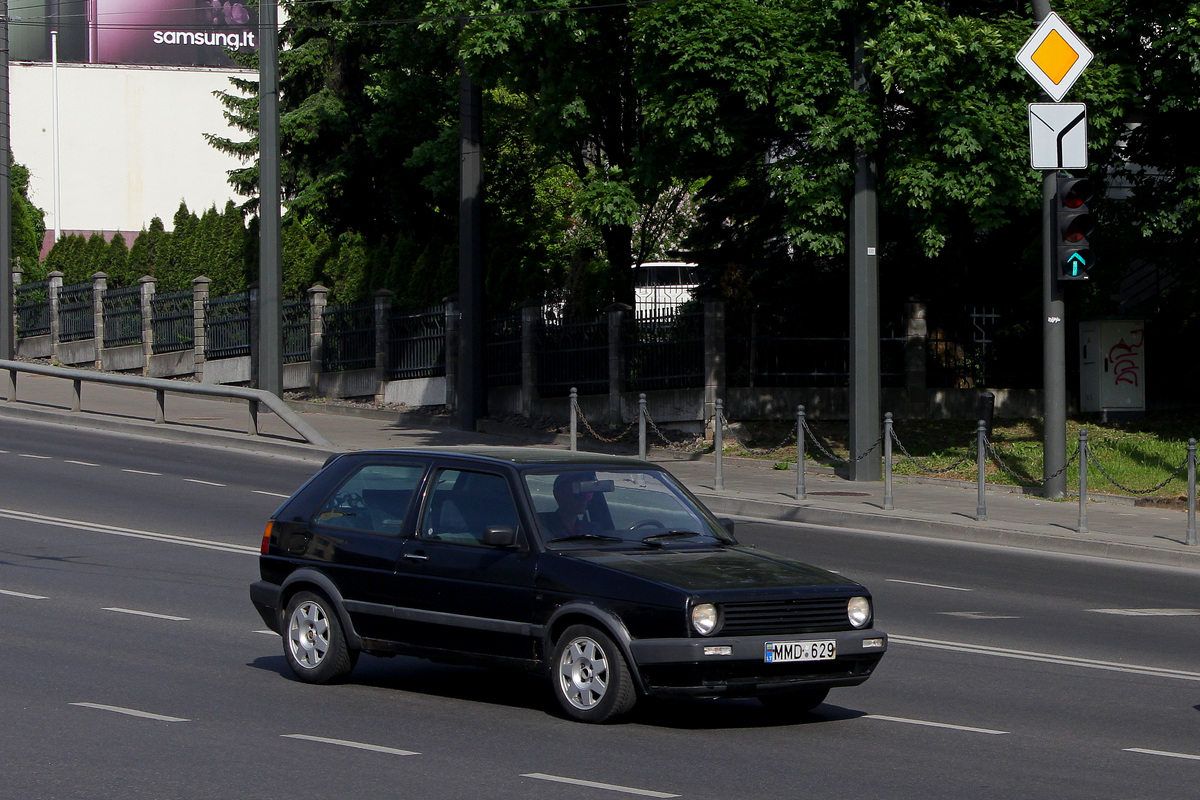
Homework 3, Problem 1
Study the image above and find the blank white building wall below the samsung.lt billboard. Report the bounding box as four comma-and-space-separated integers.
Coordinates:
10, 62, 254, 235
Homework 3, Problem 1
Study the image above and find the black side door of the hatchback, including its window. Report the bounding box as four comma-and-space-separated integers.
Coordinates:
396, 464, 536, 661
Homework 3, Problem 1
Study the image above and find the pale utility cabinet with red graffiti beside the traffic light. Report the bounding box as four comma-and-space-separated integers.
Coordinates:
1079, 319, 1146, 417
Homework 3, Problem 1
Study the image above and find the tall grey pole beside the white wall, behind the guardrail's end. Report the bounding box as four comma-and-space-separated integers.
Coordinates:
257, 0, 283, 397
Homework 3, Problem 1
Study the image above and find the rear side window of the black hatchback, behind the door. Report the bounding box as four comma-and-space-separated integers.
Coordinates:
316, 464, 425, 536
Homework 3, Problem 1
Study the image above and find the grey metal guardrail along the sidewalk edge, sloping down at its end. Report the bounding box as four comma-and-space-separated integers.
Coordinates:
0, 359, 334, 447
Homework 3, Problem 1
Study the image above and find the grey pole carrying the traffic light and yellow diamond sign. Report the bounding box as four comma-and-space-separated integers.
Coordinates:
1033, 0, 1067, 500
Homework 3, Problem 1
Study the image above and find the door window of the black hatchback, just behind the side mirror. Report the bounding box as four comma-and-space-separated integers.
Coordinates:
421, 469, 518, 547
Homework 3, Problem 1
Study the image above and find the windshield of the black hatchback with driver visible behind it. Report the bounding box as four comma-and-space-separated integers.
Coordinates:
524, 467, 733, 547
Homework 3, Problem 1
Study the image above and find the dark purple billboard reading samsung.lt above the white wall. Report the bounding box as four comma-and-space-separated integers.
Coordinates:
11, 0, 258, 67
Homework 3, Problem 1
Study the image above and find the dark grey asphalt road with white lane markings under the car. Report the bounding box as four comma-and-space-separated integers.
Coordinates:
0, 421, 1200, 800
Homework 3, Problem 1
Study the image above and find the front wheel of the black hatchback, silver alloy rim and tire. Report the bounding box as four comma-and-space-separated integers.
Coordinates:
551, 625, 637, 723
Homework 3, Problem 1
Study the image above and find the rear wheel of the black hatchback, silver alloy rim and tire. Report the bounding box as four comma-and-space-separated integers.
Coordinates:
283, 591, 358, 684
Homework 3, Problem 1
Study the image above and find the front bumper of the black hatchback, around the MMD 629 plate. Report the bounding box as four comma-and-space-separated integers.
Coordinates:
630, 628, 888, 697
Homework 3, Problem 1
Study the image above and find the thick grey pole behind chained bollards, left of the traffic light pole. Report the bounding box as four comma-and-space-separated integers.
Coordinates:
850, 20, 882, 481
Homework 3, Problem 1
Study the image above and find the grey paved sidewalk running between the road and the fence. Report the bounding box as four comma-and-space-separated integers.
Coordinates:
0, 374, 1200, 569
